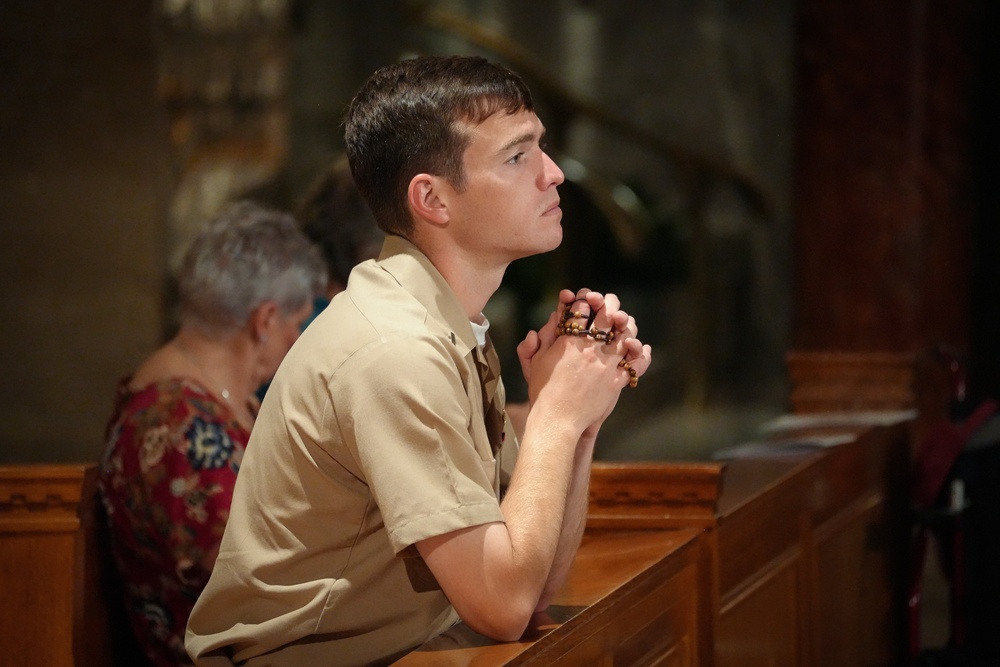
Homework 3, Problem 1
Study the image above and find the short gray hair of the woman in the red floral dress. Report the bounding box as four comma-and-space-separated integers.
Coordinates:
177, 201, 326, 333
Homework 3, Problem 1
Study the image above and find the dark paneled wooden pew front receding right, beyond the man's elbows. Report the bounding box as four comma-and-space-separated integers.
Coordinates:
714, 424, 910, 667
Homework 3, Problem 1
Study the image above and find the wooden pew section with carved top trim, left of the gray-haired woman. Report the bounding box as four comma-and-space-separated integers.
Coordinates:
0, 464, 143, 667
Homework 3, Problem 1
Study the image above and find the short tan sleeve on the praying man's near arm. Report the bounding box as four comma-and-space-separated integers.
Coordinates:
332, 335, 503, 553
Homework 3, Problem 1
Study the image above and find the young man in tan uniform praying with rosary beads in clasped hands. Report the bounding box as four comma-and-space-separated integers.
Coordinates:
186, 57, 651, 666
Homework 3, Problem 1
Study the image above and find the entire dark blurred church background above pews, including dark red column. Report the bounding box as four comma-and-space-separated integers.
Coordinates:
0, 0, 1000, 462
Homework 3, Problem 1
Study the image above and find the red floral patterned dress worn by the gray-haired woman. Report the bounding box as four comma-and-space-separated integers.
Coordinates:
100, 378, 250, 665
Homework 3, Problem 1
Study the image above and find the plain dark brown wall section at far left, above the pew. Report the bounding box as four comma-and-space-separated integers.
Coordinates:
0, 0, 173, 462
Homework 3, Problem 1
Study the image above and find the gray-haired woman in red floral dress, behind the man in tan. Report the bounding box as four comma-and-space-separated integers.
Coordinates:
100, 202, 326, 665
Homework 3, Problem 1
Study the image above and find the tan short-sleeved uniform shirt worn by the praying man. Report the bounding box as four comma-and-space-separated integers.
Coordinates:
186, 236, 517, 665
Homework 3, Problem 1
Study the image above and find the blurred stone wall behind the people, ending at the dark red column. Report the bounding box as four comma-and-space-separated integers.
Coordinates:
0, 0, 793, 461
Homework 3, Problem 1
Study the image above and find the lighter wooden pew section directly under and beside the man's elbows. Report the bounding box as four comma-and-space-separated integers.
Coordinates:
393, 463, 723, 667
